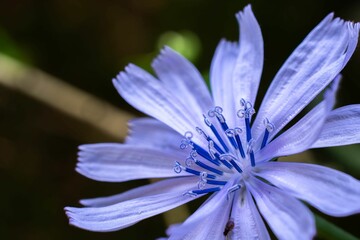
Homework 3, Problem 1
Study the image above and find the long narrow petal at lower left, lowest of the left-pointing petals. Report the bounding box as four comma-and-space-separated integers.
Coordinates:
65, 179, 202, 232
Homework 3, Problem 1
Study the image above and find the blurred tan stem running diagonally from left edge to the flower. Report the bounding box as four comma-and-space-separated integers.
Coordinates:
0, 53, 134, 139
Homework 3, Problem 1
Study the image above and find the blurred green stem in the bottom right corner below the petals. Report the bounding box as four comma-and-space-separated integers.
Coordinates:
315, 214, 359, 240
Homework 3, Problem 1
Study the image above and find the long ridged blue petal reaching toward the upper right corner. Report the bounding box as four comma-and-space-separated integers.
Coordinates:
252, 14, 360, 139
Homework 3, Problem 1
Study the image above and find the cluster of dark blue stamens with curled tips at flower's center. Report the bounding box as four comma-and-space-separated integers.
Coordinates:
174, 99, 274, 196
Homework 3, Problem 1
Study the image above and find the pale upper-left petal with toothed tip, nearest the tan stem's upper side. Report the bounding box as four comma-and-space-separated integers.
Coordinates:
113, 64, 207, 146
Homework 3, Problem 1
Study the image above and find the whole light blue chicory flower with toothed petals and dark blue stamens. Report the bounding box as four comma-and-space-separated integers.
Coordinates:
66, 6, 360, 240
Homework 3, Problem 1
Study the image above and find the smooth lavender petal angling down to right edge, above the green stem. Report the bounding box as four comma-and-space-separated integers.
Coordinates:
257, 162, 360, 217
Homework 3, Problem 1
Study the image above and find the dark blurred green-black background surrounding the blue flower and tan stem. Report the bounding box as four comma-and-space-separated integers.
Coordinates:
0, 0, 360, 240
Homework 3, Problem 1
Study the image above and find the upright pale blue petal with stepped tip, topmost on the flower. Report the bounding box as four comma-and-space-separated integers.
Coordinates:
210, 5, 264, 127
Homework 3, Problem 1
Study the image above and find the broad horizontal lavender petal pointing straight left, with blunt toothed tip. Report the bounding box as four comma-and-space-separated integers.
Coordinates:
76, 143, 188, 182
